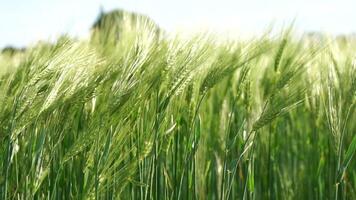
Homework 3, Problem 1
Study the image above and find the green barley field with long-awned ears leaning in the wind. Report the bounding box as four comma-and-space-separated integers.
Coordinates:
0, 10, 356, 200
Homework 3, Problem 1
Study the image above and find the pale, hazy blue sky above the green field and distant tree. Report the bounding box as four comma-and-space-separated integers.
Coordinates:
0, 0, 356, 48
